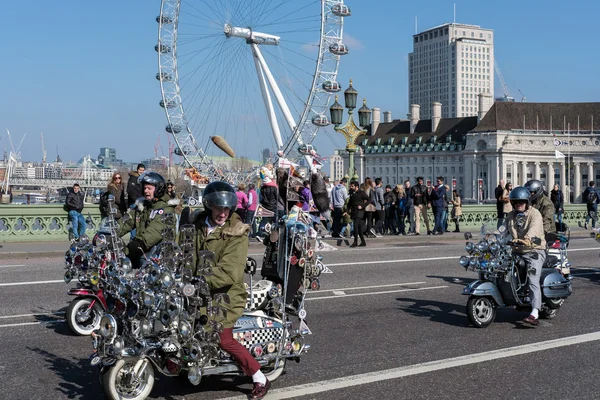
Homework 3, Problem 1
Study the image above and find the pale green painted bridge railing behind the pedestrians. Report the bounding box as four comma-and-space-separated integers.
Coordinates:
0, 204, 586, 243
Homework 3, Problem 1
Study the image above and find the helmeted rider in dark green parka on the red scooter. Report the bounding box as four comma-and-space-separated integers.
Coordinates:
119, 172, 178, 268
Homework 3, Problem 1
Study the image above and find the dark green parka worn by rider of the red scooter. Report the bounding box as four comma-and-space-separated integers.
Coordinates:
119, 194, 175, 250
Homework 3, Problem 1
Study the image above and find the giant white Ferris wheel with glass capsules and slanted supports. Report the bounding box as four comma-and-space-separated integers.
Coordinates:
155, 0, 351, 180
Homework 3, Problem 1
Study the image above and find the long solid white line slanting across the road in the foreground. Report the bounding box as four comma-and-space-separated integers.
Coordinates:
221, 332, 600, 400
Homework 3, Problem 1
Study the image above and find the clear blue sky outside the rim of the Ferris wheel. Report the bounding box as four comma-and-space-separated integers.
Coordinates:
0, 0, 600, 166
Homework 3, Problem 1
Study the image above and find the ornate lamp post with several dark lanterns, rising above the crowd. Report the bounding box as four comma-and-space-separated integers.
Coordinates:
329, 79, 371, 181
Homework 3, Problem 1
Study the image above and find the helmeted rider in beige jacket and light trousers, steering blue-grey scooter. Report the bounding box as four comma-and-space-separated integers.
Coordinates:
506, 186, 546, 325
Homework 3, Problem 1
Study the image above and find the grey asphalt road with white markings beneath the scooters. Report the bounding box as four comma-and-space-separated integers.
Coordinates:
0, 237, 600, 400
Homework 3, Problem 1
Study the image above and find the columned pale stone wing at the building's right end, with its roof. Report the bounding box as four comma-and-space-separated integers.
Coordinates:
472, 102, 600, 203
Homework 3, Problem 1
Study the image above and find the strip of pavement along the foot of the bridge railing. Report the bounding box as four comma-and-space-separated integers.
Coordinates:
0, 227, 591, 260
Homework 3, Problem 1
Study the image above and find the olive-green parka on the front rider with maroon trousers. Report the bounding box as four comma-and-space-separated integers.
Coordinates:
194, 212, 250, 328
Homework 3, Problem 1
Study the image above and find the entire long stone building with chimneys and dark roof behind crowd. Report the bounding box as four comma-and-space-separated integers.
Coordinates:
338, 100, 600, 203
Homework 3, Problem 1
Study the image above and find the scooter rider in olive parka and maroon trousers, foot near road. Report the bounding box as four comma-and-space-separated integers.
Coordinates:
189, 182, 271, 399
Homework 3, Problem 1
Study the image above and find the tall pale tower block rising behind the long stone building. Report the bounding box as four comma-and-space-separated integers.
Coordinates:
408, 24, 494, 119
